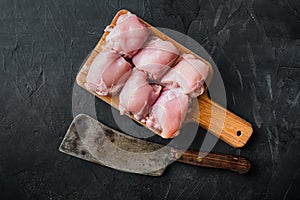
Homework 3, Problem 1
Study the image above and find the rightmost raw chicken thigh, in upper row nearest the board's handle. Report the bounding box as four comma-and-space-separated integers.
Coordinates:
161, 54, 209, 97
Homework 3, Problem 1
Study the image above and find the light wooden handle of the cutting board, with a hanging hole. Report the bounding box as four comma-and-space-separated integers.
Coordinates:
191, 94, 253, 148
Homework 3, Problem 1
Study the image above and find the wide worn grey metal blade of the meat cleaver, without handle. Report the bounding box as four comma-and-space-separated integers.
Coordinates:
59, 114, 178, 176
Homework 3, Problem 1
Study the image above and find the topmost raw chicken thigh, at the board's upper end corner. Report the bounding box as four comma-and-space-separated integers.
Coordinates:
106, 12, 150, 58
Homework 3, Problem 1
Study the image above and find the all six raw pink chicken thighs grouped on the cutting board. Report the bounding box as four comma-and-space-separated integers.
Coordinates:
85, 13, 209, 138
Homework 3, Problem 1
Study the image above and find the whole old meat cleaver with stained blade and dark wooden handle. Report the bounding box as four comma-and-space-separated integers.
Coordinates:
59, 114, 250, 176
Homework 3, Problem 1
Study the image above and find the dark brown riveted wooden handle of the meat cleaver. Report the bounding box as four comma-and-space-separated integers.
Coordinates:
177, 150, 251, 174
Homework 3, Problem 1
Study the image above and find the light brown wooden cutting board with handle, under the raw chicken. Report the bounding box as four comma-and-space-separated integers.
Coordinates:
76, 10, 253, 148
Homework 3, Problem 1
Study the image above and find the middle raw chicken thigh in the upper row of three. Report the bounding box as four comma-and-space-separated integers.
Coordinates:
132, 37, 179, 80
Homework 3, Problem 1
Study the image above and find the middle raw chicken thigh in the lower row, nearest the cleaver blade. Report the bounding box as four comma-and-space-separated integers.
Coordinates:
119, 69, 161, 120
